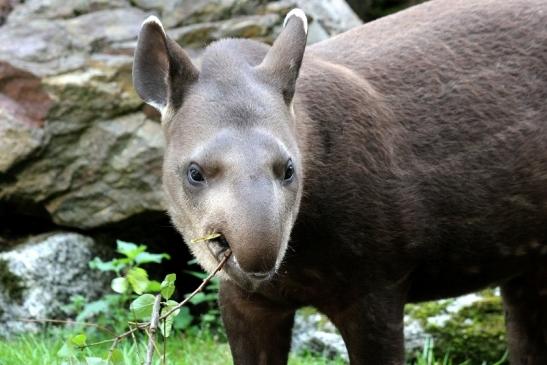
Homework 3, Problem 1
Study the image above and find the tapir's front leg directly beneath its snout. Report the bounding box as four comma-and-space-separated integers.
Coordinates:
219, 281, 295, 365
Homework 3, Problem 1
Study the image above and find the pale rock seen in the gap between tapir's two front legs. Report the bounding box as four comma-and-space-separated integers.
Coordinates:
291, 308, 349, 361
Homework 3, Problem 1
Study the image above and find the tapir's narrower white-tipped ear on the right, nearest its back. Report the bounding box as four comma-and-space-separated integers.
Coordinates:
257, 9, 308, 105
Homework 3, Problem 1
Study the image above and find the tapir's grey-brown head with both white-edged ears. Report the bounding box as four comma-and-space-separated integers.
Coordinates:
133, 9, 307, 287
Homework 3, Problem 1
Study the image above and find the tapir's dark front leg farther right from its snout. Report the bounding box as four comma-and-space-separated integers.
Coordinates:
326, 293, 405, 365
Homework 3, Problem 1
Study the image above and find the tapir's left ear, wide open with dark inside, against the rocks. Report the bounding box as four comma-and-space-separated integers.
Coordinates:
133, 16, 199, 116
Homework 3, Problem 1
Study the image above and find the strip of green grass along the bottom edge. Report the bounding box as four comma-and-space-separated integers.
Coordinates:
0, 332, 344, 365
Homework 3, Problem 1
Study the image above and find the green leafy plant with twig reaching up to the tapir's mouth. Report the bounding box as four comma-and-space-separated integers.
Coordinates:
57, 237, 229, 365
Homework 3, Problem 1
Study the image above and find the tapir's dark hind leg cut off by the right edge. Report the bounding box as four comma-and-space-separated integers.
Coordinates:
502, 259, 547, 365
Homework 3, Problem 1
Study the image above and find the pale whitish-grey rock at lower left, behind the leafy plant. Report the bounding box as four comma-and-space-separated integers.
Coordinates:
0, 233, 109, 336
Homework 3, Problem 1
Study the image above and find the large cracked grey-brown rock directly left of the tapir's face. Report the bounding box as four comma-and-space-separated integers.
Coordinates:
0, 113, 164, 229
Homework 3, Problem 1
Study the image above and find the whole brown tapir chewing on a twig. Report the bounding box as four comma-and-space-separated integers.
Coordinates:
133, 0, 547, 365
